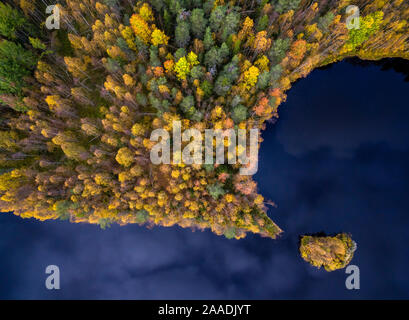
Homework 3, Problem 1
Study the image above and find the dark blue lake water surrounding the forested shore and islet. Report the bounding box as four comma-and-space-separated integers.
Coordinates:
0, 62, 409, 299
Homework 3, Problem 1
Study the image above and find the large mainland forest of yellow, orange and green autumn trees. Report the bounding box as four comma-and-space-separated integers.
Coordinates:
0, 0, 409, 239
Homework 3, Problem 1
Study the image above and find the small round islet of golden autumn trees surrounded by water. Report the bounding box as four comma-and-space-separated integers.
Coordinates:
300, 233, 356, 271
